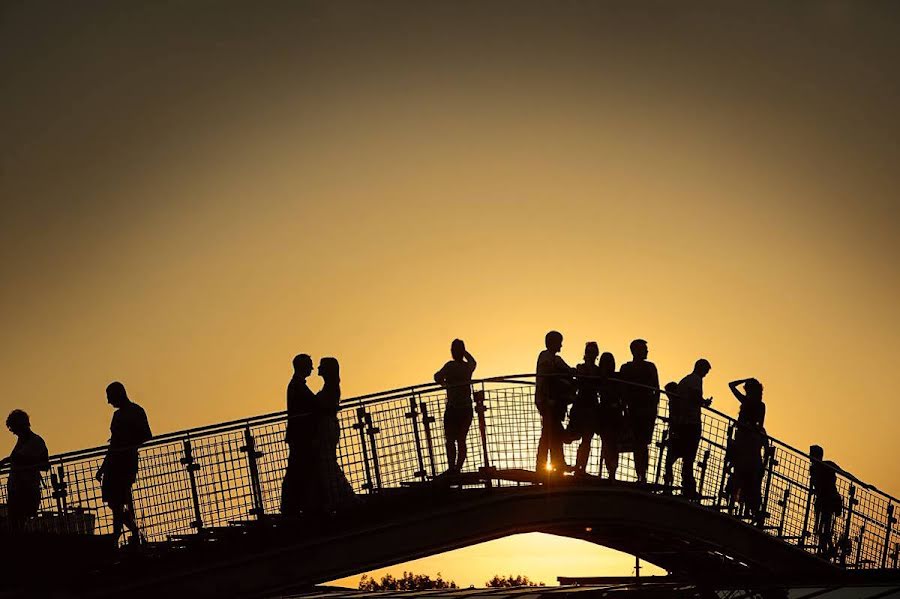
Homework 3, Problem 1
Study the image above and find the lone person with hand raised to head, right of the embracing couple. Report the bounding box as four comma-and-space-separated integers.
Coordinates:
434, 339, 477, 472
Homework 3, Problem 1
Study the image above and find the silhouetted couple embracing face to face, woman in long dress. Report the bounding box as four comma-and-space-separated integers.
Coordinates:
281, 354, 353, 515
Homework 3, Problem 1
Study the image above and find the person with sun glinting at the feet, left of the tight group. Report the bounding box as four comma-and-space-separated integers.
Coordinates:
534, 331, 575, 473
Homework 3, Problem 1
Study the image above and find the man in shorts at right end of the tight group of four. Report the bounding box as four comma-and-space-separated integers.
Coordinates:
619, 339, 659, 482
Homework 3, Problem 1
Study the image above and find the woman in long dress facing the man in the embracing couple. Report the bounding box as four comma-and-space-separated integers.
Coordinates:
314, 358, 354, 511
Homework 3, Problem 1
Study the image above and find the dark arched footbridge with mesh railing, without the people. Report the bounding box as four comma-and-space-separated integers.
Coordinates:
0, 375, 900, 597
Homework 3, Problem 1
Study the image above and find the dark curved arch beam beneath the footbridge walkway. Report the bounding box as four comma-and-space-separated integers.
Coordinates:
91, 483, 843, 596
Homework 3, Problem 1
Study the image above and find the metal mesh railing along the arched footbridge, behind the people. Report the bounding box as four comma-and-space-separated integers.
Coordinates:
0, 375, 900, 568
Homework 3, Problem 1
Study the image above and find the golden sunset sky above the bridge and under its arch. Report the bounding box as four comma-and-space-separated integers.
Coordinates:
0, 0, 900, 584
